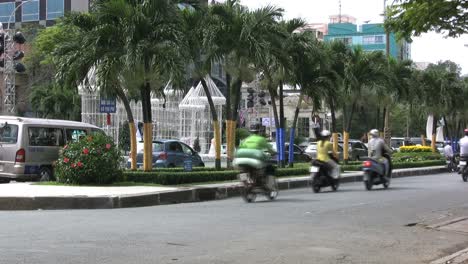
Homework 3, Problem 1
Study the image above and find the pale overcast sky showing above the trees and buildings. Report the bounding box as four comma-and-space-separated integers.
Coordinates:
241, 0, 468, 74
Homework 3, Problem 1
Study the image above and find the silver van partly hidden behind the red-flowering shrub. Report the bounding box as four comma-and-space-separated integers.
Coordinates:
0, 116, 103, 183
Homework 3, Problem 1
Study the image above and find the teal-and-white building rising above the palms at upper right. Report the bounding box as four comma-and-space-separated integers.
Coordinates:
325, 16, 411, 59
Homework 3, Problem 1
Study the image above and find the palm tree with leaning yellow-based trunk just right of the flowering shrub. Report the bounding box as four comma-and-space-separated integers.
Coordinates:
53, 10, 142, 170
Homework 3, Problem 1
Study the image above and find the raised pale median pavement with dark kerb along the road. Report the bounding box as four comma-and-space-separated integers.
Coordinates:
0, 166, 446, 210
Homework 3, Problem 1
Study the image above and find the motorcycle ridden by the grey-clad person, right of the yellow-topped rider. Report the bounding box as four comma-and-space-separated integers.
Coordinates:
362, 155, 392, 191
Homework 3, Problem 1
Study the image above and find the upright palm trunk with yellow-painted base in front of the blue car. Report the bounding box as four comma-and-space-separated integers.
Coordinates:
140, 82, 153, 171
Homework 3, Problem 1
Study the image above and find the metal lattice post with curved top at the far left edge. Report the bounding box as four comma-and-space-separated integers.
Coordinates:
0, 0, 39, 114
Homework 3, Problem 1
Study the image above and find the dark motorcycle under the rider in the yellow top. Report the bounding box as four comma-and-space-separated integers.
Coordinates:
310, 160, 340, 193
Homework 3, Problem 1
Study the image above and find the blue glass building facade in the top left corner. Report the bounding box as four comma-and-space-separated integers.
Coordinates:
0, 0, 89, 28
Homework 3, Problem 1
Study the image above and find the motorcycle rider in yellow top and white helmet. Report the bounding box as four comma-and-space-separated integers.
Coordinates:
317, 130, 340, 179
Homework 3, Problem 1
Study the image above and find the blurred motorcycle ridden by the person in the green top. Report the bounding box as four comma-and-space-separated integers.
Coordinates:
233, 150, 278, 203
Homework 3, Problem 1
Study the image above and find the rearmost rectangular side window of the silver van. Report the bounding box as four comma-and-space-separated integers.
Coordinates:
28, 127, 63, 147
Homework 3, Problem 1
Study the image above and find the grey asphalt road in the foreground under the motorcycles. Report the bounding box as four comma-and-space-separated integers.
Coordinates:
0, 174, 468, 264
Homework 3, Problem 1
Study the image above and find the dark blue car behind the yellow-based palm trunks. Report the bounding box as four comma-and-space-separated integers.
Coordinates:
127, 140, 205, 168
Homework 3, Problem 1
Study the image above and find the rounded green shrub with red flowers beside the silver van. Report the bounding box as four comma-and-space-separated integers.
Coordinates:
55, 134, 122, 184
